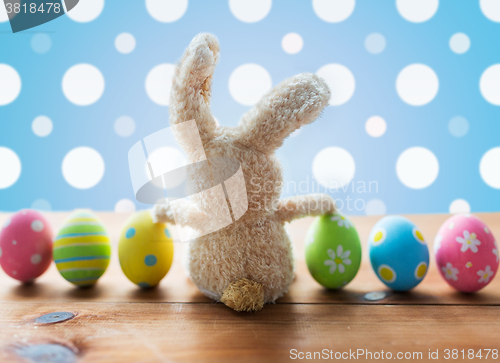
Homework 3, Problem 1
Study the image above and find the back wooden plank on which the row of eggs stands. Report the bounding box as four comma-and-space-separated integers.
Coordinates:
0, 213, 500, 305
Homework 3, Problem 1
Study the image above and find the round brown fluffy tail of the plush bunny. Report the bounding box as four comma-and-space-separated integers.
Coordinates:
220, 278, 264, 311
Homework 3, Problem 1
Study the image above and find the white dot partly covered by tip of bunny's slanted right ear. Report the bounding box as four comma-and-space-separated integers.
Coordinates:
316, 63, 356, 106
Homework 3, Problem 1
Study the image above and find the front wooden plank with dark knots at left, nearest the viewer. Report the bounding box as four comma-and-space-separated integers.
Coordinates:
0, 303, 500, 362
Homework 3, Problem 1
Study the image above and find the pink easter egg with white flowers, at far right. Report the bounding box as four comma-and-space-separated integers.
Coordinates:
434, 214, 498, 292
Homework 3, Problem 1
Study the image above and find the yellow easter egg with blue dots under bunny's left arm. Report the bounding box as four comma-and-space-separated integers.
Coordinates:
118, 211, 174, 288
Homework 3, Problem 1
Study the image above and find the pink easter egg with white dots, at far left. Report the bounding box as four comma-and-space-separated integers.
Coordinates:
0, 209, 52, 282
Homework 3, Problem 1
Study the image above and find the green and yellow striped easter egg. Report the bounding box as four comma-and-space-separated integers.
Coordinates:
54, 210, 111, 286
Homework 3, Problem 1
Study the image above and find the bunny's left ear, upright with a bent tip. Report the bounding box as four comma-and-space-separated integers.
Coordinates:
169, 33, 219, 144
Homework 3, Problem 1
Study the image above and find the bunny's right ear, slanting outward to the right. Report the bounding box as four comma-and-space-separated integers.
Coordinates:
237, 73, 330, 153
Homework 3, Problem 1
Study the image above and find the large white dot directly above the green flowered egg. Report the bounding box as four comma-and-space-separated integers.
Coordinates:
312, 147, 356, 189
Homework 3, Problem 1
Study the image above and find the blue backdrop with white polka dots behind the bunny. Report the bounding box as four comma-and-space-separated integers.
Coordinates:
0, 0, 500, 214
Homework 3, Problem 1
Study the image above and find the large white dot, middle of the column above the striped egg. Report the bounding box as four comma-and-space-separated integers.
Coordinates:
62, 63, 104, 106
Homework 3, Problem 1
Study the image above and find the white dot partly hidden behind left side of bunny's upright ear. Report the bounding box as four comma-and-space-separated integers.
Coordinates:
146, 63, 175, 106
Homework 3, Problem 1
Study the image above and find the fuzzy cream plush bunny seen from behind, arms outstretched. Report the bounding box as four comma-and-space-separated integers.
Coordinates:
152, 34, 335, 311
